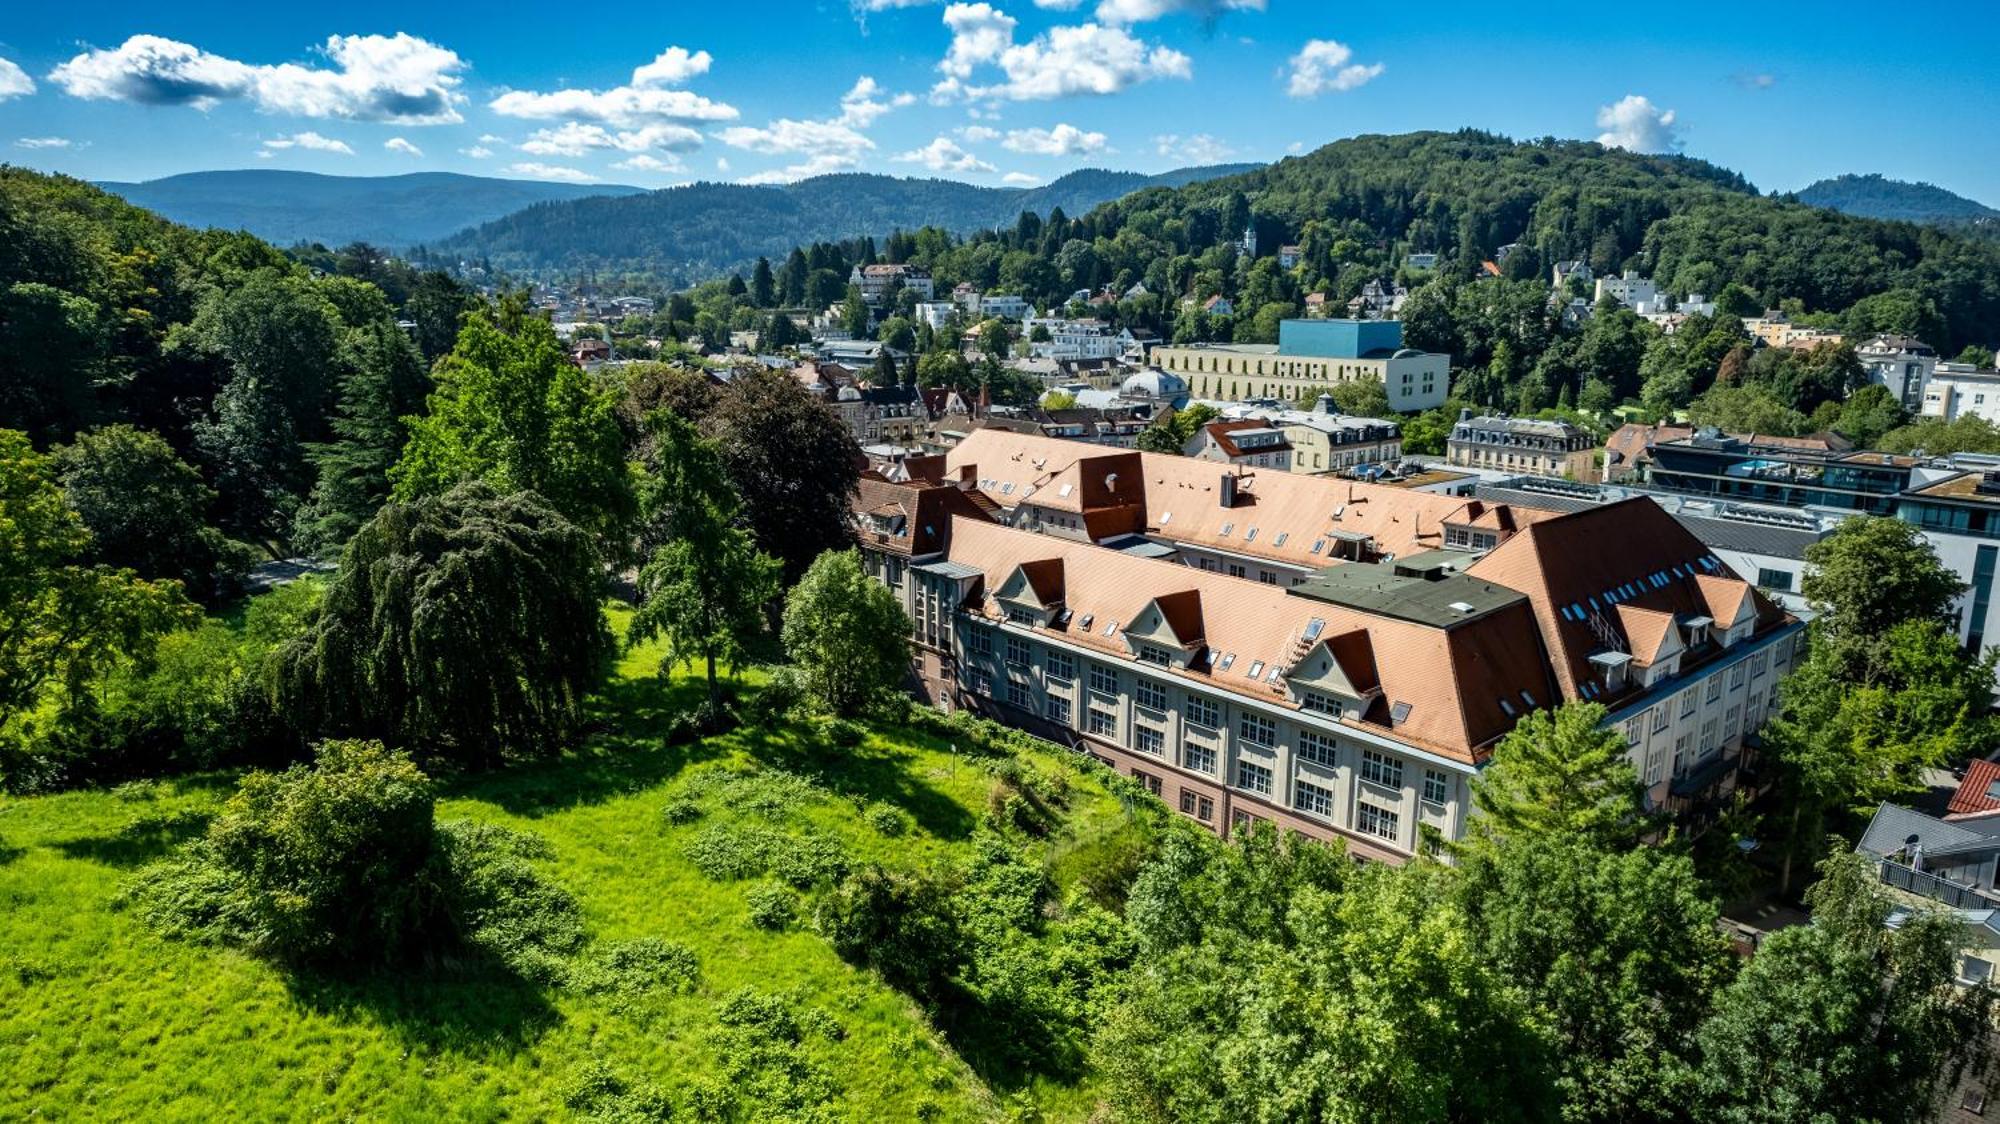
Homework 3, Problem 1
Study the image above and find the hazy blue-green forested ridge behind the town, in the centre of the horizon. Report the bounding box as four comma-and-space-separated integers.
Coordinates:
432, 164, 1252, 282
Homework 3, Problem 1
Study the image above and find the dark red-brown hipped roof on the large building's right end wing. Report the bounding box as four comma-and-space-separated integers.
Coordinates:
1466, 496, 1788, 698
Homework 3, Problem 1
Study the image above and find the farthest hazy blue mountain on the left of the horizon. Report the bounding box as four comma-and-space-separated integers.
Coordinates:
98, 168, 644, 248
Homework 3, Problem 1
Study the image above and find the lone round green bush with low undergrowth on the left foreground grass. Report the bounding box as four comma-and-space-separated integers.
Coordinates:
124, 742, 584, 982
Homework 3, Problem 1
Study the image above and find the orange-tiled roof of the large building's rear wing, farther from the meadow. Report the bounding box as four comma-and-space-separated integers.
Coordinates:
946, 428, 1558, 568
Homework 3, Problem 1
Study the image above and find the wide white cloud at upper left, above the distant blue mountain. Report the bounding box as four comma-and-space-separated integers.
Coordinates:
50, 32, 466, 124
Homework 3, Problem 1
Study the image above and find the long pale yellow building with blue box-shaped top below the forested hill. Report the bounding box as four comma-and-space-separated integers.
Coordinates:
1152, 320, 1452, 412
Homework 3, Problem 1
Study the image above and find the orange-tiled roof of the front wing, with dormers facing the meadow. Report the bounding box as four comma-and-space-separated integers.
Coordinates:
948, 520, 1556, 764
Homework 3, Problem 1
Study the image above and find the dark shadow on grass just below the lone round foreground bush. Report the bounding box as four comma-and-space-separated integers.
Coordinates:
286, 958, 562, 1056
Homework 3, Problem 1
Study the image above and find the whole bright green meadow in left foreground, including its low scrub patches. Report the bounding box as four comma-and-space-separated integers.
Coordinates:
0, 616, 1148, 1120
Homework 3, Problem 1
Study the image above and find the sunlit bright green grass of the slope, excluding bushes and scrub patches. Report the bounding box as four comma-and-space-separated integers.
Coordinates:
0, 616, 1126, 1120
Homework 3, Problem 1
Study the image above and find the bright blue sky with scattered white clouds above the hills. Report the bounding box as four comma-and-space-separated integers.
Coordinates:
0, 0, 2000, 206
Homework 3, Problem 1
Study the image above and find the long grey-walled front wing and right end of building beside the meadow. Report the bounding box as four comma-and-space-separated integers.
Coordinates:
864, 494, 1800, 862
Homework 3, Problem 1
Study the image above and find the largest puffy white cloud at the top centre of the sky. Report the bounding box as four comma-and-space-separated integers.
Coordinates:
930, 4, 1194, 104
